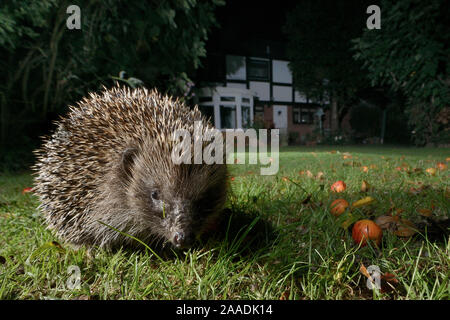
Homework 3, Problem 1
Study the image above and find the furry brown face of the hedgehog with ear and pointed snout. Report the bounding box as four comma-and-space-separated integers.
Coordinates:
121, 148, 209, 248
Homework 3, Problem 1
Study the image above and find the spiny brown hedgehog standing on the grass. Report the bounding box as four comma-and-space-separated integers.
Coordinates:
33, 85, 227, 248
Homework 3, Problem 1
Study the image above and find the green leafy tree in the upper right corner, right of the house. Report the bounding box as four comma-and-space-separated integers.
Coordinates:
354, 0, 450, 145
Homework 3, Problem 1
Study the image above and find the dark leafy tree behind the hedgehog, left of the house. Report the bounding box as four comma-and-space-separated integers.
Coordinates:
0, 0, 223, 148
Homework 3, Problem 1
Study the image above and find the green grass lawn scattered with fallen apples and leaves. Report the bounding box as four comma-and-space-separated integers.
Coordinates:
0, 146, 450, 300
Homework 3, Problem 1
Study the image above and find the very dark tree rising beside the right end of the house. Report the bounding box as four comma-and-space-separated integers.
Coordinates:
284, 0, 369, 130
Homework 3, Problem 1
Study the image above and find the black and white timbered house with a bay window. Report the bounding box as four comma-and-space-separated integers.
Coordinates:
195, 45, 329, 144
